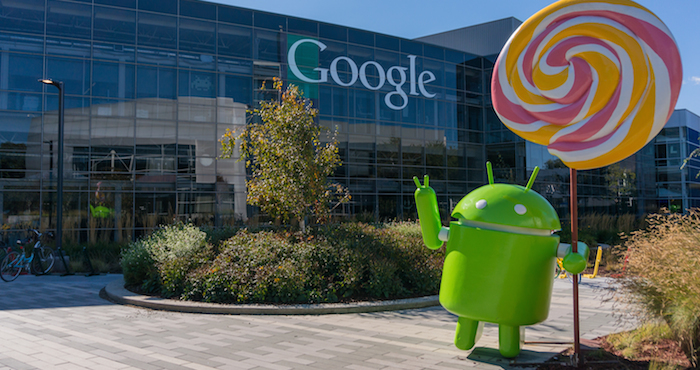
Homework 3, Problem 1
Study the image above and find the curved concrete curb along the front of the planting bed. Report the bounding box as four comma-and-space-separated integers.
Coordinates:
104, 279, 440, 315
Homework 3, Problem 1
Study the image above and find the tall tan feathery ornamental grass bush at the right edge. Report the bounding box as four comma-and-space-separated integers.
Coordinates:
621, 210, 700, 366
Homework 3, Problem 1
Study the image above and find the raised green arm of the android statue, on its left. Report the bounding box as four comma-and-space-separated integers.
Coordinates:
413, 175, 446, 249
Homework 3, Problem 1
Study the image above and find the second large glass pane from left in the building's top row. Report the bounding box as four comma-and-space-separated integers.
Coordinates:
46, 0, 92, 39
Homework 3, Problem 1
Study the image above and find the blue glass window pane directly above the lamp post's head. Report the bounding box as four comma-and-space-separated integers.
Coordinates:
46, 57, 90, 95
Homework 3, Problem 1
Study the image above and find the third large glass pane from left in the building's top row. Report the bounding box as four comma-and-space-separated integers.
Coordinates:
93, 6, 136, 44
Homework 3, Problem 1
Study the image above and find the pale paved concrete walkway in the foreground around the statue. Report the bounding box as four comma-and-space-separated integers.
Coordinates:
0, 275, 630, 370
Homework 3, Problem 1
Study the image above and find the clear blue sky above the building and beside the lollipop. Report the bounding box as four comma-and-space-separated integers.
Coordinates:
216, 0, 700, 115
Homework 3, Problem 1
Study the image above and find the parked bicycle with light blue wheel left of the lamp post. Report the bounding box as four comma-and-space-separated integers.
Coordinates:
0, 229, 56, 282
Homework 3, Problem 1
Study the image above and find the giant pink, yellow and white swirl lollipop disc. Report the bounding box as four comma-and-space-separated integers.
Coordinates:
491, 0, 682, 169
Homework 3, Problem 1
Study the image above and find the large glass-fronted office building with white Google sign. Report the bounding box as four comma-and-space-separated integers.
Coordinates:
0, 0, 700, 243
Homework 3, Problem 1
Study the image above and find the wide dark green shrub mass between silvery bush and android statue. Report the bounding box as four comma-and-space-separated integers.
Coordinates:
182, 223, 444, 303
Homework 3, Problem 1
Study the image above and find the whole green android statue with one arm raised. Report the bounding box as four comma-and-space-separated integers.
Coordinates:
413, 163, 588, 358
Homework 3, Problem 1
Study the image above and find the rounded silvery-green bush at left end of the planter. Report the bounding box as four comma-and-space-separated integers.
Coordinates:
122, 223, 209, 297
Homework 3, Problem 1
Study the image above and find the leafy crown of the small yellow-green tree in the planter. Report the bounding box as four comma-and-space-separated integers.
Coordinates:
221, 78, 350, 231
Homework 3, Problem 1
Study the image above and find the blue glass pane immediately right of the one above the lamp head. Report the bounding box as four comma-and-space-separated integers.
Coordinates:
92, 62, 134, 99
